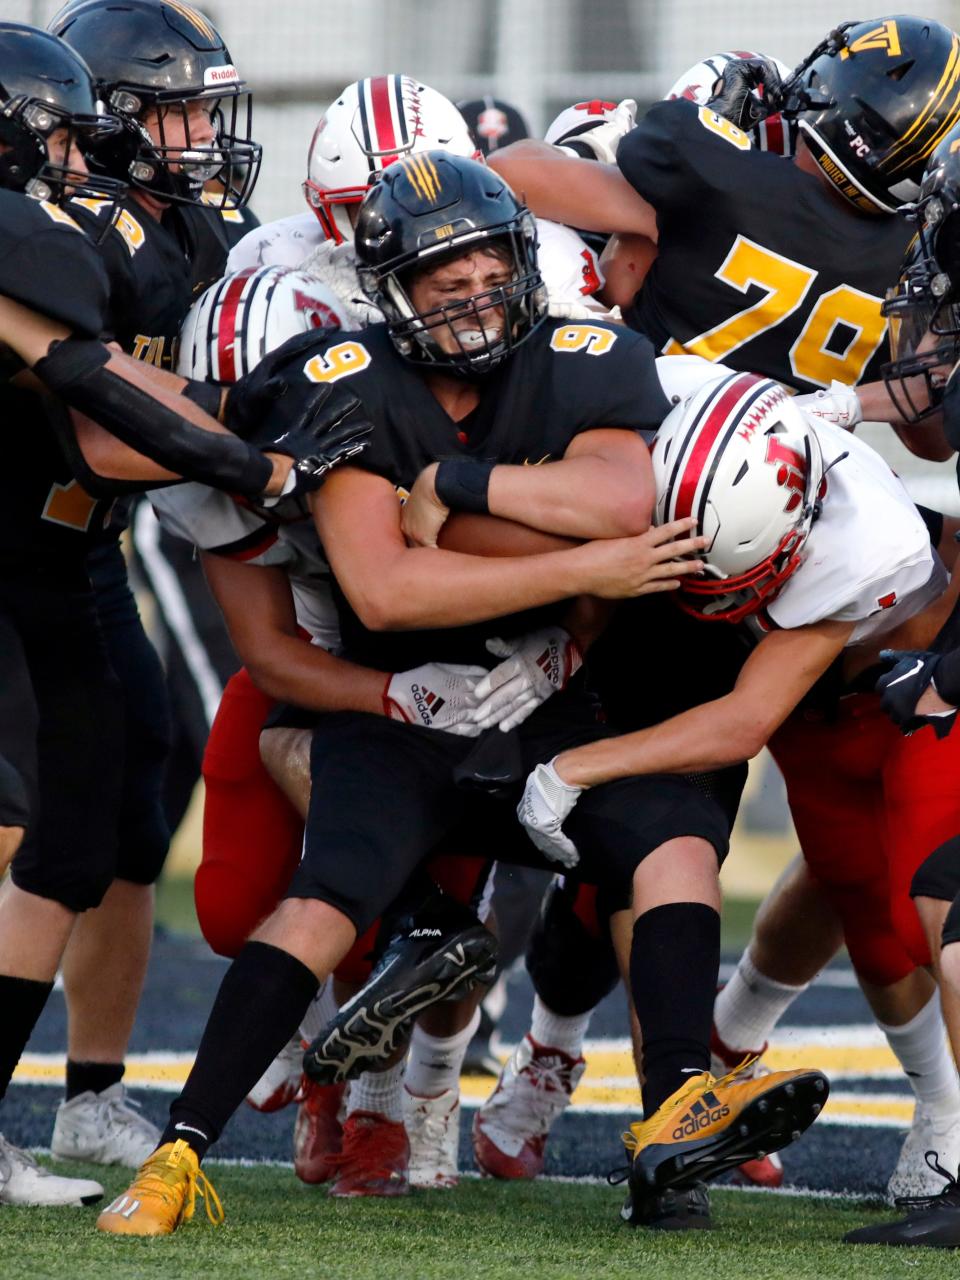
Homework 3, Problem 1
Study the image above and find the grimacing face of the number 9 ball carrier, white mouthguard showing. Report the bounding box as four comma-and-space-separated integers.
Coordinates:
410, 248, 513, 356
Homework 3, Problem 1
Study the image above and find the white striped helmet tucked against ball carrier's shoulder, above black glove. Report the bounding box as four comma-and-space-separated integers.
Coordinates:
177, 266, 343, 383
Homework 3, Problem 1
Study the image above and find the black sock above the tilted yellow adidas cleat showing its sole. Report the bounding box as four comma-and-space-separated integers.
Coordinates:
630, 902, 719, 1117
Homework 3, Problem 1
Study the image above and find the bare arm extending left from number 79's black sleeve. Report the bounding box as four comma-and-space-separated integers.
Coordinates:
488, 138, 657, 241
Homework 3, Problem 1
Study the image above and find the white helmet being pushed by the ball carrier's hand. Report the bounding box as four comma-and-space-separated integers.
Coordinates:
652, 374, 823, 622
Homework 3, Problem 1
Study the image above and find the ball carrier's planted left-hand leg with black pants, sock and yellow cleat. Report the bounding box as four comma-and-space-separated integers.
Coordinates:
99, 713, 476, 1235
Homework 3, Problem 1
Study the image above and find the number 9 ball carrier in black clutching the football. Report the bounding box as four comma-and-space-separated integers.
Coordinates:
99, 152, 827, 1235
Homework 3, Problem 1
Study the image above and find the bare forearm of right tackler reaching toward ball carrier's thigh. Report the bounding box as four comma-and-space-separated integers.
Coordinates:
556, 696, 771, 787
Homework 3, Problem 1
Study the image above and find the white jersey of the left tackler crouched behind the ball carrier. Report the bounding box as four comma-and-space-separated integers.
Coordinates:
150, 483, 340, 653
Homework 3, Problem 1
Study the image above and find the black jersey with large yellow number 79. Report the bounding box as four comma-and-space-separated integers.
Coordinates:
617, 100, 913, 390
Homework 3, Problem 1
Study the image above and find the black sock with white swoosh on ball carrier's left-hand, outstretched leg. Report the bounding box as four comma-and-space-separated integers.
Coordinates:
160, 942, 320, 1160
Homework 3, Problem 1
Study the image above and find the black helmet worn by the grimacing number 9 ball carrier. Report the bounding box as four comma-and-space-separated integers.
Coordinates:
356, 151, 547, 376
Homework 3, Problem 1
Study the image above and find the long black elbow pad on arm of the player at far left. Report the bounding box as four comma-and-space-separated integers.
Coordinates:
33, 338, 273, 497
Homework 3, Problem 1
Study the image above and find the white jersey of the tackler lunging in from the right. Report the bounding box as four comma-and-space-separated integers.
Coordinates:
657, 356, 947, 645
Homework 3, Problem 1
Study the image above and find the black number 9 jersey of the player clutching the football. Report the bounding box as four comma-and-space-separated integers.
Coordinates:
241, 320, 671, 671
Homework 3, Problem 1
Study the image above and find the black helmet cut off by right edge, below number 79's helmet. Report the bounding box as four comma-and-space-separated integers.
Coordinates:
881, 125, 960, 422
